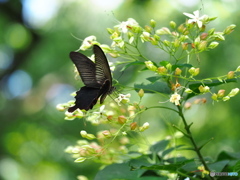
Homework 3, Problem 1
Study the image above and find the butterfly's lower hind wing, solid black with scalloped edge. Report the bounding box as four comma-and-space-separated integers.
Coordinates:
68, 86, 101, 112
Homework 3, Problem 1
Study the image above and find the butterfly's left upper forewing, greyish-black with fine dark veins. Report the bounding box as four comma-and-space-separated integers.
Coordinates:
70, 52, 101, 88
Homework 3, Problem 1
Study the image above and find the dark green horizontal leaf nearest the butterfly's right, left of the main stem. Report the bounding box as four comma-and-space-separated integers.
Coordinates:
134, 82, 171, 94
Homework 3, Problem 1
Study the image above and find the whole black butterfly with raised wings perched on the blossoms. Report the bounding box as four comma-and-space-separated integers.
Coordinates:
68, 45, 114, 112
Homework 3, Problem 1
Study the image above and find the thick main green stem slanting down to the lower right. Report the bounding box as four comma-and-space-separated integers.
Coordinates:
177, 106, 214, 179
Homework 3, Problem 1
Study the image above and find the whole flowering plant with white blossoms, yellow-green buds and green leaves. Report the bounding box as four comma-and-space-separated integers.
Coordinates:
57, 11, 240, 179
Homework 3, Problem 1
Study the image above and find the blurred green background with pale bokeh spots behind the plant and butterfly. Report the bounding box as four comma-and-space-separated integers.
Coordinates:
0, 0, 240, 180
